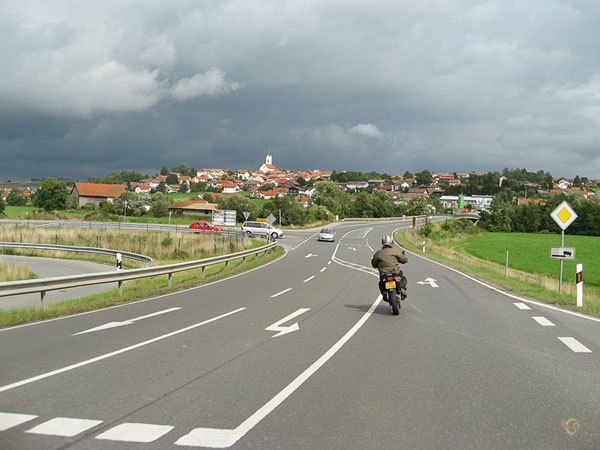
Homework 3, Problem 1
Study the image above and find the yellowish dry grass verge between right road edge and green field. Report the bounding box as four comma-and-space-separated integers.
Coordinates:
395, 231, 600, 317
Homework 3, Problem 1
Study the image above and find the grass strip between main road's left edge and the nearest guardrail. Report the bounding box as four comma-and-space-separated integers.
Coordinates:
0, 247, 284, 328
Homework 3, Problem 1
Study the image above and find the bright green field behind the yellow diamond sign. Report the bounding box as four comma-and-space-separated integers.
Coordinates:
455, 233, 600, 287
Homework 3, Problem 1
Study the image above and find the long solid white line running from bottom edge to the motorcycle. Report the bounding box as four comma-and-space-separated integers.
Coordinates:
175, 295, 381, 448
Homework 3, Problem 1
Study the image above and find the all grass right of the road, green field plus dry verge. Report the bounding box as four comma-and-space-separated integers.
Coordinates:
396, 221, 600, 316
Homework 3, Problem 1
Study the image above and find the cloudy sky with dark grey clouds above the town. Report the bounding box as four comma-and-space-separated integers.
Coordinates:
0, 0, 600, 181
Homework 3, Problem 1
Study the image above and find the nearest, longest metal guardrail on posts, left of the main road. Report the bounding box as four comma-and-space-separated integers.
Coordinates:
0, 243, 277, 310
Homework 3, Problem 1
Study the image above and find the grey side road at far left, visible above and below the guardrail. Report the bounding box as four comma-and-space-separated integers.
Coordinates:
0, 255, 115, 311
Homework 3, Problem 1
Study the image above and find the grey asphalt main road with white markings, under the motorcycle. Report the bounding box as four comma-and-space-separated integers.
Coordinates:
0, 222, 600, 450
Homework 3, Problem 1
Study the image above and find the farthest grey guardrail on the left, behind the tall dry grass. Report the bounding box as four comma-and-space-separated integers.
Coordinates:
0, 219, 243, 236
